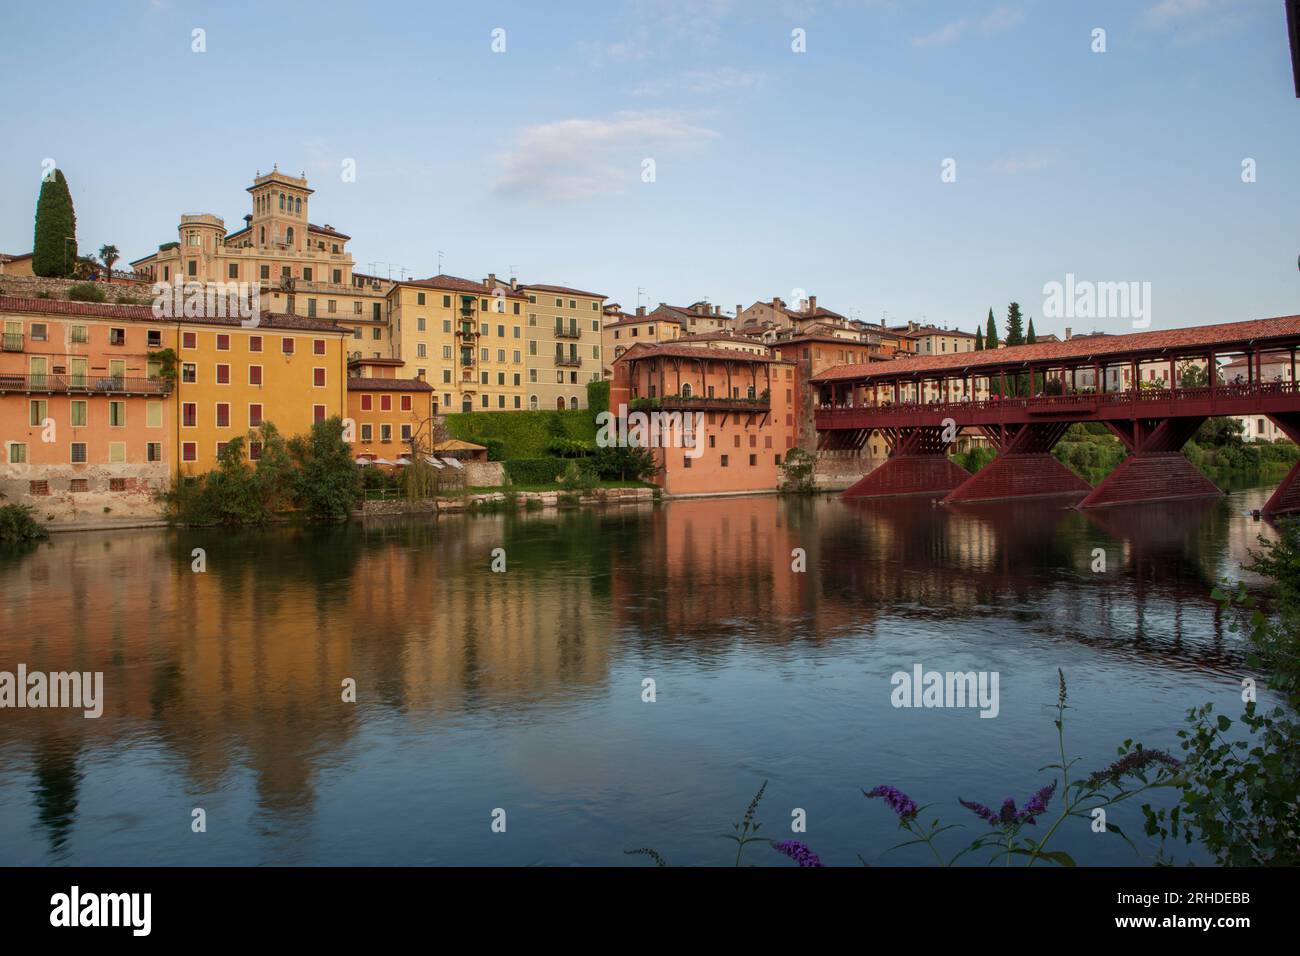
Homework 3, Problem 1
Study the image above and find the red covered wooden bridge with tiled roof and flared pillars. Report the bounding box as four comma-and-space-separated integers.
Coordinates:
813, 316, 1300, 514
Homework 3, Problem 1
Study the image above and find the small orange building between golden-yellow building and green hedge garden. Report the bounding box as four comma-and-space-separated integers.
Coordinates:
347, 359, 438, 460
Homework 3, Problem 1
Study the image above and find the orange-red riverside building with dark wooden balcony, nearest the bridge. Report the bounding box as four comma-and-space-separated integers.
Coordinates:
610, 343, 796, 494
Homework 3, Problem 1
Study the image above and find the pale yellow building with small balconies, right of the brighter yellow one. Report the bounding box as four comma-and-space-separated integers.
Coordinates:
517, 285, 605, 410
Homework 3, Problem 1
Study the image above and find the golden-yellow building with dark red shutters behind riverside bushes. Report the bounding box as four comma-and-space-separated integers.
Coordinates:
178, 312, 348, 475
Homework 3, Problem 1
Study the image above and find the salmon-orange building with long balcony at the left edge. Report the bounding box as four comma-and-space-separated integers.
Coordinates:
0, 297, 173, 499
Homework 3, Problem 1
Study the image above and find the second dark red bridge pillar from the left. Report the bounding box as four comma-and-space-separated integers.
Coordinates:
944, 421, 1092, 505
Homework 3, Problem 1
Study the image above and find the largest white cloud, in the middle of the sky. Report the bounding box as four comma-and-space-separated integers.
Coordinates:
493, 111, 719, 203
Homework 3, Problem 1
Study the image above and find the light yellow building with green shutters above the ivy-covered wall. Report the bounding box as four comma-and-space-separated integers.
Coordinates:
387, 274, 528, 414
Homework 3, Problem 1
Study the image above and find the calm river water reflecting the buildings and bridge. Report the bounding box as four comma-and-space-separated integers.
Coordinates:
0, 488, 1268, 865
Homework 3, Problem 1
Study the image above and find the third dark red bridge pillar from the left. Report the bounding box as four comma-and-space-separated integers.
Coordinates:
1079, 416, 1223, 507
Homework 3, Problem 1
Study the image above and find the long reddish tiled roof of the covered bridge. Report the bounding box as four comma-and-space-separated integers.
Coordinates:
811, 315, 1300, 382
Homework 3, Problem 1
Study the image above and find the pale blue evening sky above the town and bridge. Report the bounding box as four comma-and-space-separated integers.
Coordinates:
0, 0, 1300, 333
